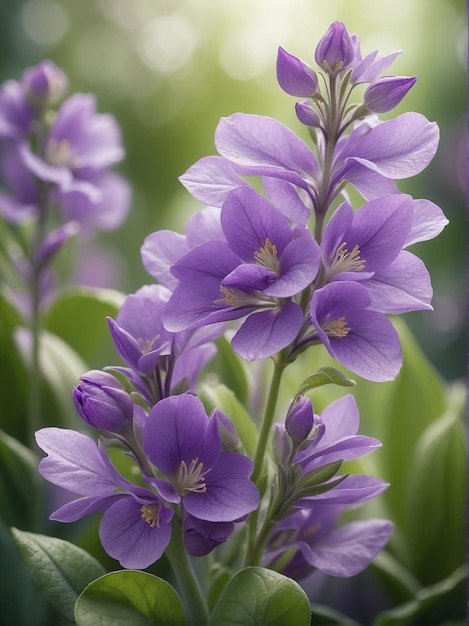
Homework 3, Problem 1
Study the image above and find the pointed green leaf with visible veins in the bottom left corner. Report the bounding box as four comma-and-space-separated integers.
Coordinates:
11, 528, 104, 621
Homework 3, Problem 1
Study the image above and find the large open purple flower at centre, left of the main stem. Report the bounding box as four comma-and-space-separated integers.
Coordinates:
163, 187, 319, 360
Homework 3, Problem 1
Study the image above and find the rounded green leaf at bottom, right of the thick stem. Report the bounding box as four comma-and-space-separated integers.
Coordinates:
209, 567, 310, 626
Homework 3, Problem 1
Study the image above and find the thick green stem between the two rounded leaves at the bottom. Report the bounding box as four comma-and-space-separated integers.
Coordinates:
166, 512, 209, 626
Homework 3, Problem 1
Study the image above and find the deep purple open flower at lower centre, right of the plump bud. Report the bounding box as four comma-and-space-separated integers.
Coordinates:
143, 394, 259, 522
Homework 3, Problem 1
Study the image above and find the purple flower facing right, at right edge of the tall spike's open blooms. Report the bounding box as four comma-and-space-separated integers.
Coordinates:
321, 194, 447, 313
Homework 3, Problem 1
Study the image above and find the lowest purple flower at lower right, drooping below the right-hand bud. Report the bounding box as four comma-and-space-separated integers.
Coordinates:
264, 504, 393, 579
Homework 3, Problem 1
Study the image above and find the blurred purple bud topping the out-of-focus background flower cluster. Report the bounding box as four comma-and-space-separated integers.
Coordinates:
21, 60, 67, 108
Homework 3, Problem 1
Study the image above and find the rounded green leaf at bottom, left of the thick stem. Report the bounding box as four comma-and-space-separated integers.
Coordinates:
75, 570, 186, 626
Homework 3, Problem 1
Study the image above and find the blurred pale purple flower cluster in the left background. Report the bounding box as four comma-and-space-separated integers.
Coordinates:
0, 61, 130, 230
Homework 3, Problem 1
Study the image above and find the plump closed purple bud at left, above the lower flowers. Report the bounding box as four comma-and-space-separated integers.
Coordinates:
72, 370, 134, 432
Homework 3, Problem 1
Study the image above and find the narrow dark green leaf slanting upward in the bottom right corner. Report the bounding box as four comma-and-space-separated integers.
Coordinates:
373, 566, 467, 626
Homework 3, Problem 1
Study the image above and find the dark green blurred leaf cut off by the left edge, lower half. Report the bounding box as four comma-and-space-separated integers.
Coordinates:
0, 431, 39, 526
